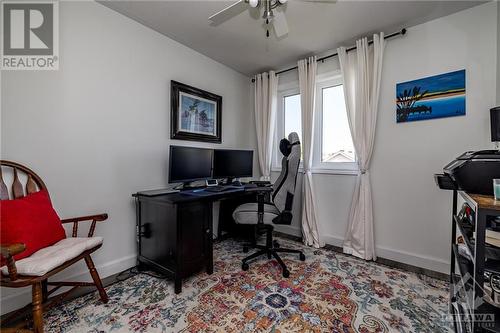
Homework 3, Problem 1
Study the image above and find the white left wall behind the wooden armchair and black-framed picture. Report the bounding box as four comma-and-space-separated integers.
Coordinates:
1, 2, 256, 313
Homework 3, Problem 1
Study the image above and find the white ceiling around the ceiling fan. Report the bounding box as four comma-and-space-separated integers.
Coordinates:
101, 0, 484, 75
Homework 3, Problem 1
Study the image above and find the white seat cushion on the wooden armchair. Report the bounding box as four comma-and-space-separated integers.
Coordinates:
2, 237, 102, 276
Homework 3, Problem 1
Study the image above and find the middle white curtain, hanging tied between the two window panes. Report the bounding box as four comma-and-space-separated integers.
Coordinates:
298, 57, 324, 248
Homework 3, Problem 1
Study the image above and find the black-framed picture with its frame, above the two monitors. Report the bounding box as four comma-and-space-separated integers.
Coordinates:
170, 81, 222, 143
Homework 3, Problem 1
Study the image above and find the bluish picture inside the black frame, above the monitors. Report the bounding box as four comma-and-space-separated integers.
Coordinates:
179, 92, 217, 136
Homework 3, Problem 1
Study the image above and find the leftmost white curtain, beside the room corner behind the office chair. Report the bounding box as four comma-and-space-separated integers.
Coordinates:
254, 71, 278, 180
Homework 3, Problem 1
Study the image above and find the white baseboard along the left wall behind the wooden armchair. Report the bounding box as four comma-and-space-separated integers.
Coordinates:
0, 254, 137, 315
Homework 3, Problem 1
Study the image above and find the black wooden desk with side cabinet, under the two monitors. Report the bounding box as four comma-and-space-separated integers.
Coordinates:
133, 188, 255, 294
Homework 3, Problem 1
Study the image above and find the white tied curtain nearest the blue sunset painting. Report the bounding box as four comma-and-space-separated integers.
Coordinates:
338, 33, 385, 260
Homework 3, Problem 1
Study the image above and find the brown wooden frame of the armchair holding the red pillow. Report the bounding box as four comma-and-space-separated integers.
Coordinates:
0, 160, 108, 333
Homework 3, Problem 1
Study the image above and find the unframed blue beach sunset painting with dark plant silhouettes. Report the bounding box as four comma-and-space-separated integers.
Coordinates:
396, 70, 465, 123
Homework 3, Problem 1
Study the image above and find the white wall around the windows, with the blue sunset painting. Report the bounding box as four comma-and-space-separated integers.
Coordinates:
280, 2, 500, 272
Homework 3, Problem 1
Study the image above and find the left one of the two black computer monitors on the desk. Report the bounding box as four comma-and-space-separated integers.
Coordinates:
168, 146, 213, 187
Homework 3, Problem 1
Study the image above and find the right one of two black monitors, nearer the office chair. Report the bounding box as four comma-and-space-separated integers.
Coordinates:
213, 149, 253, 183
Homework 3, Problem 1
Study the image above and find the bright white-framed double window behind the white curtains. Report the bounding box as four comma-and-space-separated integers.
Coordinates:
273, 73, 357, 173
